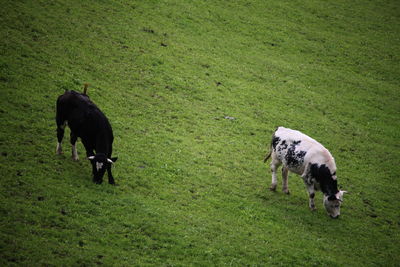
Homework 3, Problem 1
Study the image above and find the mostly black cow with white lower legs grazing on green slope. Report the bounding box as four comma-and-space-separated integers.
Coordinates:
56, 84, 117, 184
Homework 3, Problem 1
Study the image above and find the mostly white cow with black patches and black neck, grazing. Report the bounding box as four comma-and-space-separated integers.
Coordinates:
264, 127, 345, 218
